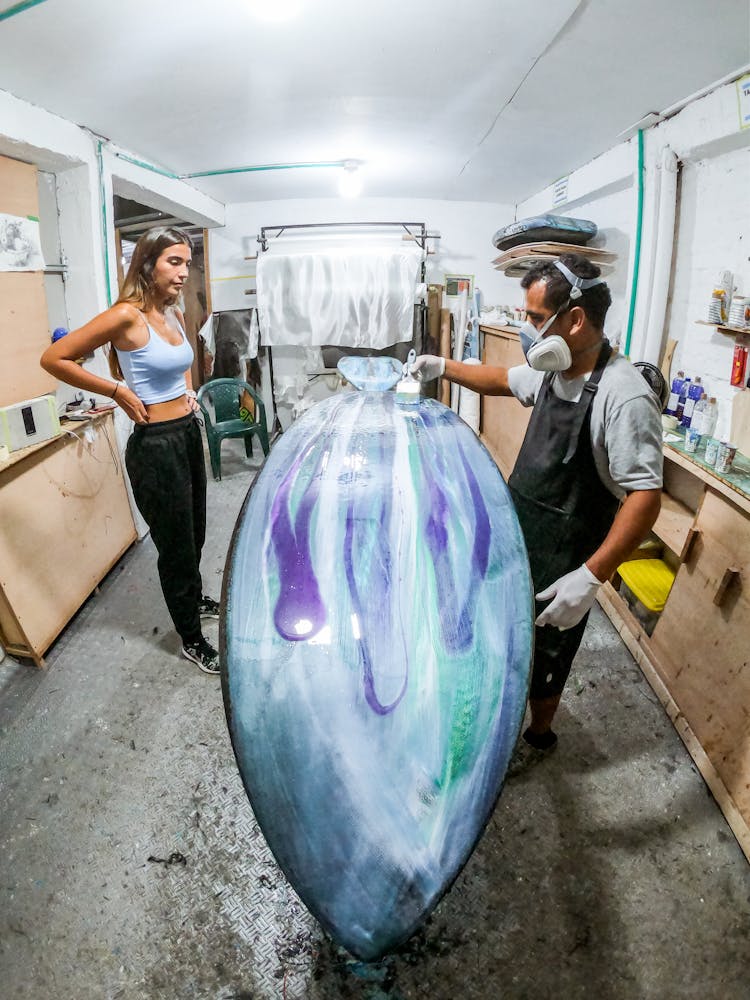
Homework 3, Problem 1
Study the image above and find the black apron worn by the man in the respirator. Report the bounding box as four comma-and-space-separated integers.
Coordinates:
508, 340, 619, 698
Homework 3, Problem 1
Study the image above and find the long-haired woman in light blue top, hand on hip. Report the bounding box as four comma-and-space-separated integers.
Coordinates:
41, 227, 219, 674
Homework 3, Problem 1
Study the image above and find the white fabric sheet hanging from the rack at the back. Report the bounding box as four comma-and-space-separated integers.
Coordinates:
256, 247, 422, 350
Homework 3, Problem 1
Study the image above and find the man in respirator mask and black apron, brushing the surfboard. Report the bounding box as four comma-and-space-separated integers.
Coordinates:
412, 254, 662, 762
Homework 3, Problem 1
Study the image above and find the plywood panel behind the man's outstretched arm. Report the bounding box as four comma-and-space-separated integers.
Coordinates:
480, 328, 531, 480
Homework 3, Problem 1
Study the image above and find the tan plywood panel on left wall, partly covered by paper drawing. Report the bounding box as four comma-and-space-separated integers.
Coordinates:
0, 156, 57, 406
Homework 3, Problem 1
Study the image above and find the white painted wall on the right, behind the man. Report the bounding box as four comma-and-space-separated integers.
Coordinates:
517, 83, 750, 435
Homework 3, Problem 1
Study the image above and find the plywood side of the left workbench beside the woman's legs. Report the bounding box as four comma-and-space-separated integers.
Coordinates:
0, 415, 136, 653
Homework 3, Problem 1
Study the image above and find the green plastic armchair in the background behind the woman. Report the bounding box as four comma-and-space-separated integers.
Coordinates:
197, 378, 269, 479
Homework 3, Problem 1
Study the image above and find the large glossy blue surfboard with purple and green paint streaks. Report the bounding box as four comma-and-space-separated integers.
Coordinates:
221, 373, 533, 961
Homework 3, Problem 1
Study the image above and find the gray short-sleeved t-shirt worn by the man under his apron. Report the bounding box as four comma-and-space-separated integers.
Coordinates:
508, 354, 663, 500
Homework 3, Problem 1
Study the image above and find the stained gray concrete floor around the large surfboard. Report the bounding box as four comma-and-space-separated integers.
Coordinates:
0, 442, 750, 1000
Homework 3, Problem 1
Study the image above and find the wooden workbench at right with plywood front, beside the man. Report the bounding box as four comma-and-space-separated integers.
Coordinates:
599, 444, 750, 860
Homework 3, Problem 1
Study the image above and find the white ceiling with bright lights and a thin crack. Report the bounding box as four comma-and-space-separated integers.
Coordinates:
0, 0, 750, 203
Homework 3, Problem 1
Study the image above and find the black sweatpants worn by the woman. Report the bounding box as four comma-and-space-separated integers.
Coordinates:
125, 414, 206, 642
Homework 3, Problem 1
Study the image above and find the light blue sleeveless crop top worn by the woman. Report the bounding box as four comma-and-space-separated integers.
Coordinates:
115, 323, 193, 403
